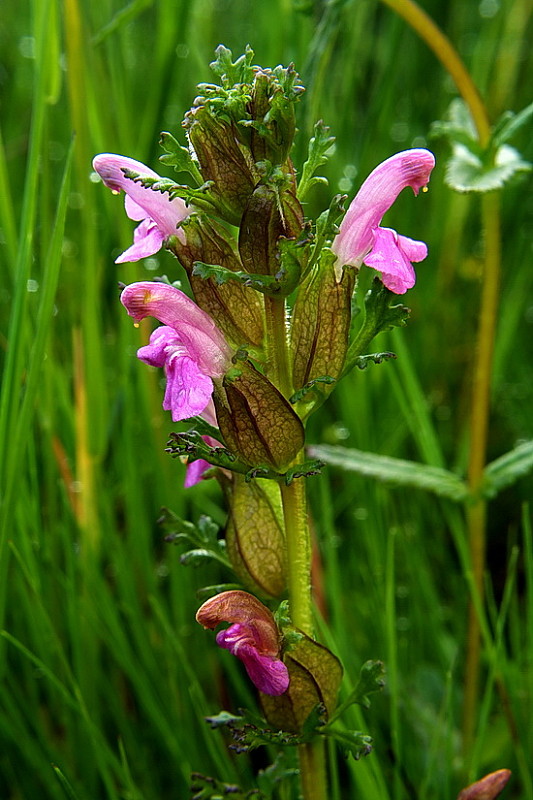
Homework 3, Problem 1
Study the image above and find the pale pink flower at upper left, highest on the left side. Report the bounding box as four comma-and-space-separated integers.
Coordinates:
93, 153, 191, 264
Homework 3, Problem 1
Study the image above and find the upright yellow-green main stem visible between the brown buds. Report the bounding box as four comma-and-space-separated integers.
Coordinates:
265, 297, 328, 800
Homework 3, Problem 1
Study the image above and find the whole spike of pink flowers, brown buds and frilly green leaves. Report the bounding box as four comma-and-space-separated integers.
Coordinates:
93, 49, 435, 700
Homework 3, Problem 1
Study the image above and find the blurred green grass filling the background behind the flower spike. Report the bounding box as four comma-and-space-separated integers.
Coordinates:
0, 0, 533, 800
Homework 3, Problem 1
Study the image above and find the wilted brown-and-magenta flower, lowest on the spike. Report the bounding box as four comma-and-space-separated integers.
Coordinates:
196, 590, 289, 696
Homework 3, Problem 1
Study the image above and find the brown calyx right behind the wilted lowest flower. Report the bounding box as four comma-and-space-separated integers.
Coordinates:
261, 632, 342, 733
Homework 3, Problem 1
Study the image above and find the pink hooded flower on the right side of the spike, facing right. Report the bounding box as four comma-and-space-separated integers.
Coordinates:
331, 149, 435, 294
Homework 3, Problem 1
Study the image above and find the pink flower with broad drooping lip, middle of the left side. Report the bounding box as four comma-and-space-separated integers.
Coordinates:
120, 281, 231, 422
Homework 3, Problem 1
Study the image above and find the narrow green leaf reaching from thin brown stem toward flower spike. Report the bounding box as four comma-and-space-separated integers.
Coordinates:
308, 445, 469, 503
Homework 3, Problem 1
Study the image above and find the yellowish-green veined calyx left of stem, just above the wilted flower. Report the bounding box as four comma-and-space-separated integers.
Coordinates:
226, 474, 287, 597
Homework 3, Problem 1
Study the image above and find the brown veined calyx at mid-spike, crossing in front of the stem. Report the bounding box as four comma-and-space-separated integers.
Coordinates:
213, 361, 304, 472
